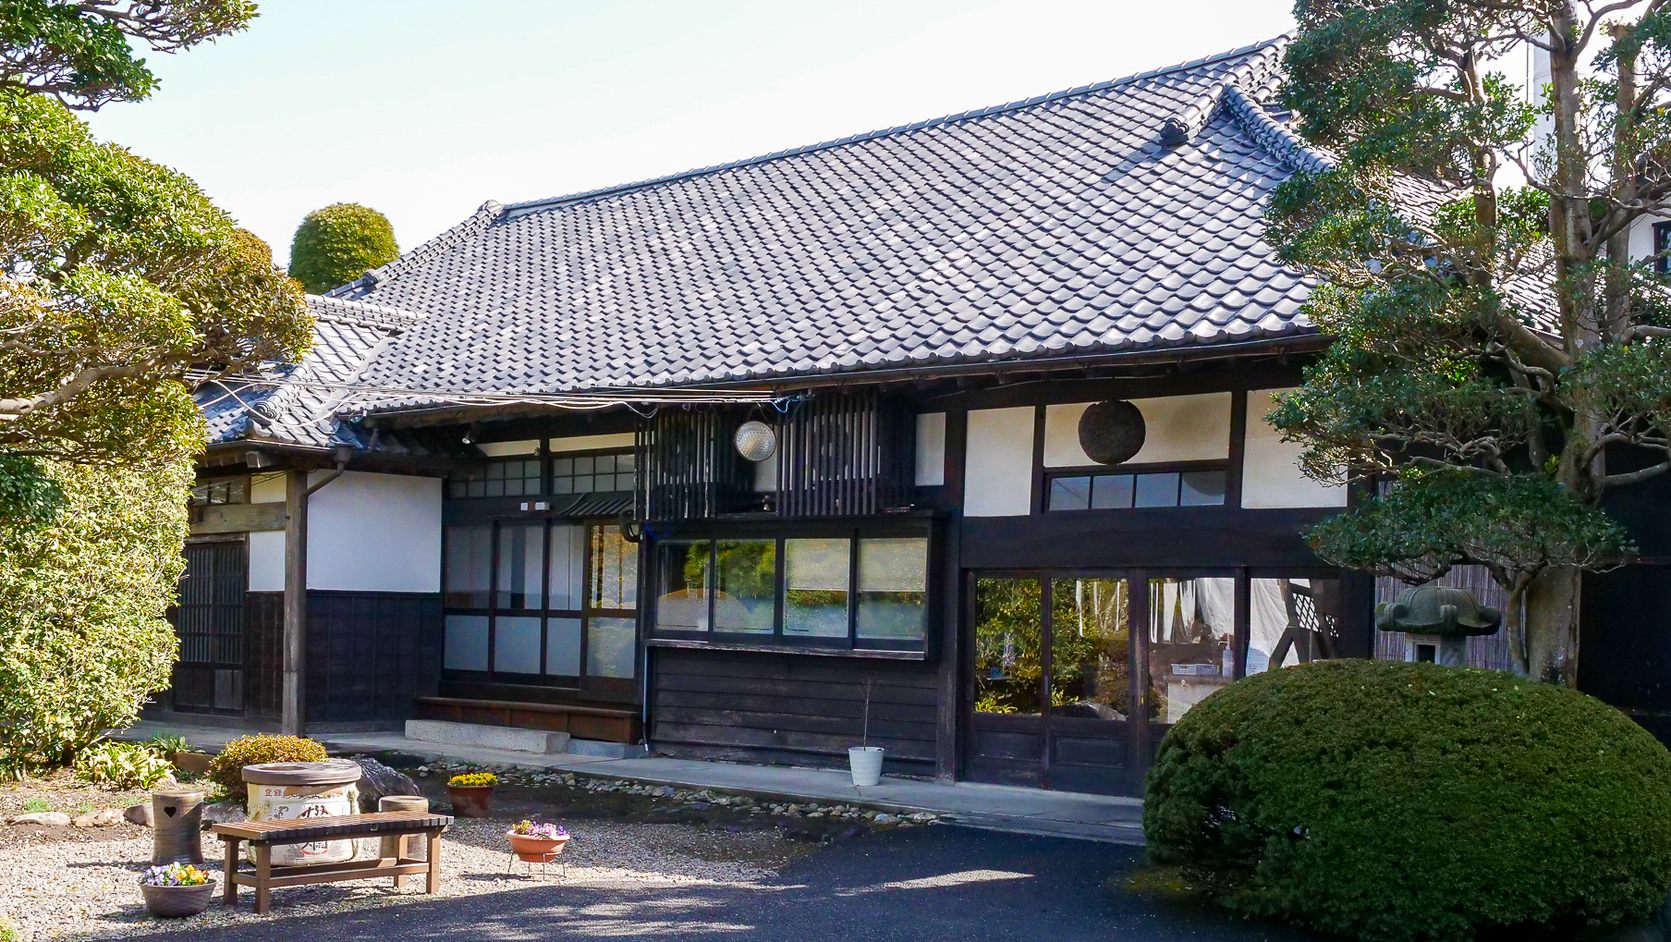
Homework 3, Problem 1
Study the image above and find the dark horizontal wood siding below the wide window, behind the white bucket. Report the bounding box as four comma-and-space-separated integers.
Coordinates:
650, 648, 937, 775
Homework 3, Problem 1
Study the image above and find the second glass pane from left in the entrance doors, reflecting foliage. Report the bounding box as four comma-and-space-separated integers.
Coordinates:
1049, 580, 1131, 720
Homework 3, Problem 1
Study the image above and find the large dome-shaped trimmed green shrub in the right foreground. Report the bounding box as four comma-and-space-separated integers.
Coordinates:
1143, 660, 1671, 942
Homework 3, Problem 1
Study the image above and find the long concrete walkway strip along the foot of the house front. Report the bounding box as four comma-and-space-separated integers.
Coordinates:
124, 722, 1143, 845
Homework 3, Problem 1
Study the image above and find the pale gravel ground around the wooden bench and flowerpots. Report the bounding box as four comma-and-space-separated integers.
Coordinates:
0, 767, 929, 942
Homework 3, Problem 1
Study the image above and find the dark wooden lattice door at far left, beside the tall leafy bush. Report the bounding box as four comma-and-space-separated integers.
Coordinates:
170, 541, 249, 715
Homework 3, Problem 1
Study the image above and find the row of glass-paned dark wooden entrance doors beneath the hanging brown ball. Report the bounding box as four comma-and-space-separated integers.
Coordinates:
964, 570, 1343, 795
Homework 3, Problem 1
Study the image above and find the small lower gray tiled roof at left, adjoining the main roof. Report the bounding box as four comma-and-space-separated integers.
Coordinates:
196, 296, 419, 448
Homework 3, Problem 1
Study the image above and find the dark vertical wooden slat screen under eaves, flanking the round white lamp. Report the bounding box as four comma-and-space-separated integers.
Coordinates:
635, 393, 916, 519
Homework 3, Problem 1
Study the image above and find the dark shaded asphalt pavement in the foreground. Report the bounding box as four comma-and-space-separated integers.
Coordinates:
147, 825, 1317, 942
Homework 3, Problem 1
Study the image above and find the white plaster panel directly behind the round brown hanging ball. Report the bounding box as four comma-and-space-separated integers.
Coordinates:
1044, 393, 1230, 468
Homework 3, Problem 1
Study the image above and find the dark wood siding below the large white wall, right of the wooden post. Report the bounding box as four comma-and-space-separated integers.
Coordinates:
306, 591, 441, 725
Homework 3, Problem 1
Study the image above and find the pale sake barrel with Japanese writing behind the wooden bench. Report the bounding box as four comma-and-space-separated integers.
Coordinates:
244, 758, 361, 867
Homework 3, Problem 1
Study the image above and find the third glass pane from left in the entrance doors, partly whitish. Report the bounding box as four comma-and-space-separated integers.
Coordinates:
1148, 578, 1237, 723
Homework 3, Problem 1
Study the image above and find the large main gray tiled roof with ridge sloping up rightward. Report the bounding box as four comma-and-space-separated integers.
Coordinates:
319, 40, 1322, 408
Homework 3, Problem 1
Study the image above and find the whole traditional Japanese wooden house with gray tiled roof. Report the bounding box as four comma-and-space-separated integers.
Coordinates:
157, 42, 1671, 793
